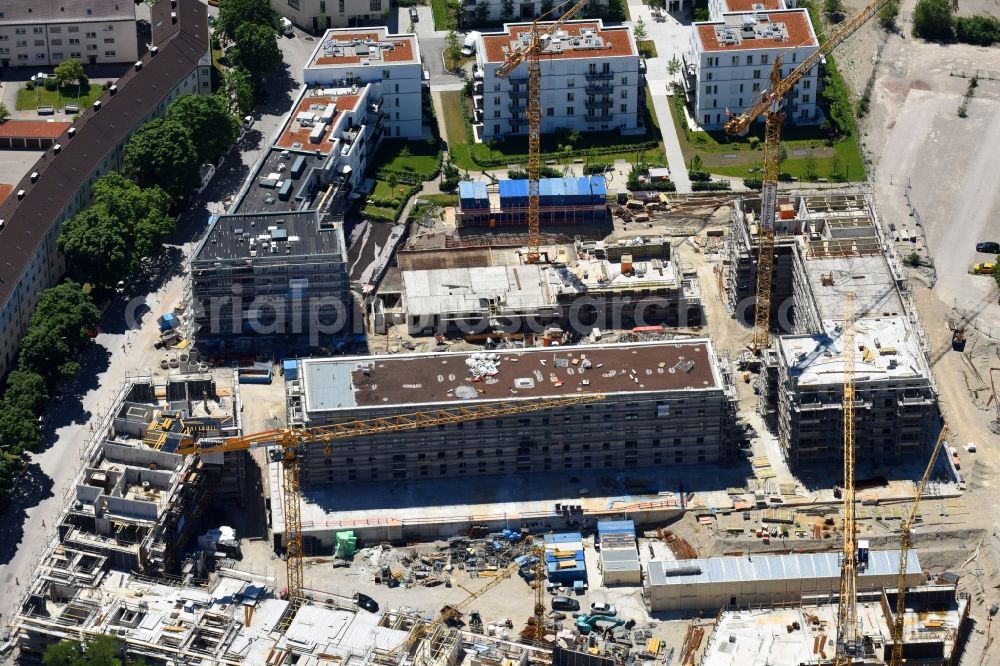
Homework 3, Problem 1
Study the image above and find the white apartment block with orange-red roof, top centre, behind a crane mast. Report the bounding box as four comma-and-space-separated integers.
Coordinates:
473, 19, 644, 140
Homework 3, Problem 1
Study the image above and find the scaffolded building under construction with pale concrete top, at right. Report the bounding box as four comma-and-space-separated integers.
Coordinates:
726, 190, 938, 466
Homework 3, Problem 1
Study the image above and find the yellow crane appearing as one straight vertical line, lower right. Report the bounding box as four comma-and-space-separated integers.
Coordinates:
834, 292, 861, 666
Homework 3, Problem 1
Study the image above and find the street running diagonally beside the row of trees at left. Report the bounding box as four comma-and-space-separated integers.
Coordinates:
0, 26, 316, 641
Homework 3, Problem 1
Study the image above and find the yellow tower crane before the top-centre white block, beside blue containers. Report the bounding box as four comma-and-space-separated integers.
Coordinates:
496, 0, 590, 264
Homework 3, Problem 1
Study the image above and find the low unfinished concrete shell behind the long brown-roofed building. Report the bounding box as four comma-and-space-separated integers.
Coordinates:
370, 237, 703, 335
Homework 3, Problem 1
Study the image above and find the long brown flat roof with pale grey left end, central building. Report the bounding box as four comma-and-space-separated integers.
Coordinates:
301, 339, 722, 415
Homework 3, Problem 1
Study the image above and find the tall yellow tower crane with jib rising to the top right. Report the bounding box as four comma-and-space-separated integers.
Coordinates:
724, 0, 888, 354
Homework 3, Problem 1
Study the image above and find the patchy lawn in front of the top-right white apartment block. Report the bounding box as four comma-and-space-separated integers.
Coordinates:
670, 89, 865, 181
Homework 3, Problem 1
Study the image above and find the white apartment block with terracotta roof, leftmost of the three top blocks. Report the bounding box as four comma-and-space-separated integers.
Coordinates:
303, 26, 424, 139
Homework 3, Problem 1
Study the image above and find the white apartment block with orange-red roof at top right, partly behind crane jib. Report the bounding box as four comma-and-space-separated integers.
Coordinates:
683, 9, 823, 130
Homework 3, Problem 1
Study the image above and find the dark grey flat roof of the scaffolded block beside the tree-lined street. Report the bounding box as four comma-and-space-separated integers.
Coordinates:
193, 211, 343, 261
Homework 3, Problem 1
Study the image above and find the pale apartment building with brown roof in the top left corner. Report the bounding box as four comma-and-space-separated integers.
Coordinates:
0, 0, 139, 68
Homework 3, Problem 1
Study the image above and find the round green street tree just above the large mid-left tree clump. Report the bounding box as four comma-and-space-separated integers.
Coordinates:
122, 119, 200, 201
